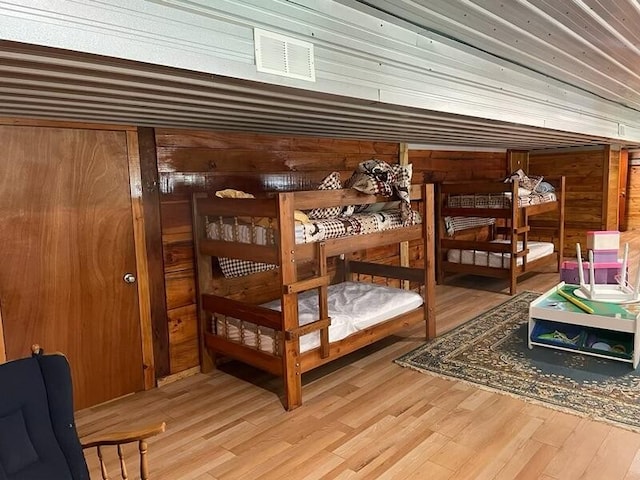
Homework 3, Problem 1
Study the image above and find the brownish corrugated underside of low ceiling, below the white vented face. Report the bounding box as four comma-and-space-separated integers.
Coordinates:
0, 44, 624, 148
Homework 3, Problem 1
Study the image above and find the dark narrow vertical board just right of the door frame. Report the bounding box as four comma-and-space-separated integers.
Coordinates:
138, 127, 171, 378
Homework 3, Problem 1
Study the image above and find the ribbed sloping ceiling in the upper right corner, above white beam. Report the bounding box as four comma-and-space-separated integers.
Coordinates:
358, 0, 640, 111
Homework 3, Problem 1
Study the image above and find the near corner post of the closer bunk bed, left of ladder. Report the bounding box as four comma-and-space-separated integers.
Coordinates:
277, 193, 302, 410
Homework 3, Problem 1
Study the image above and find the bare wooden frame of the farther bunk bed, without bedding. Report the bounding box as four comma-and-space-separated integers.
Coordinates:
436, 177, 565, 295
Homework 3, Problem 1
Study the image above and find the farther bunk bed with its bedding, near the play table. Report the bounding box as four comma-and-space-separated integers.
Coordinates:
436, 177, 565, 295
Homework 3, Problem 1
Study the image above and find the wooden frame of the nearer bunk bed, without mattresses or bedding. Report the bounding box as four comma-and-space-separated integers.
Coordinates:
193, 184, 435, 410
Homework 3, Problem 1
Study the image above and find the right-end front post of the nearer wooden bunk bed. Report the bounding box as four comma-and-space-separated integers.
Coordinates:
422, 183, 436, 340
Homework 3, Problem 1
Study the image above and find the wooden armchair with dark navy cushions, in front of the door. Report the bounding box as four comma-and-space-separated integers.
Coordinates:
0, 345, 165, 480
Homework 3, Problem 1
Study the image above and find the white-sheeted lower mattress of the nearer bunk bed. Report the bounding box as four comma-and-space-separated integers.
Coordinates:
212, 282, 423, 355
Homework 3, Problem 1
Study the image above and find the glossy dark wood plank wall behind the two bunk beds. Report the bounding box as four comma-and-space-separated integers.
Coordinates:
155, 134, 616, 374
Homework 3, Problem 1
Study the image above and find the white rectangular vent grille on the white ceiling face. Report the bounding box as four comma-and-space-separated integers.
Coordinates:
253, 28, 316, 82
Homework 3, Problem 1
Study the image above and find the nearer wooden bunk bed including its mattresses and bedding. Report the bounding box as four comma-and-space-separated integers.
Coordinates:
193, 184, 435, 410
